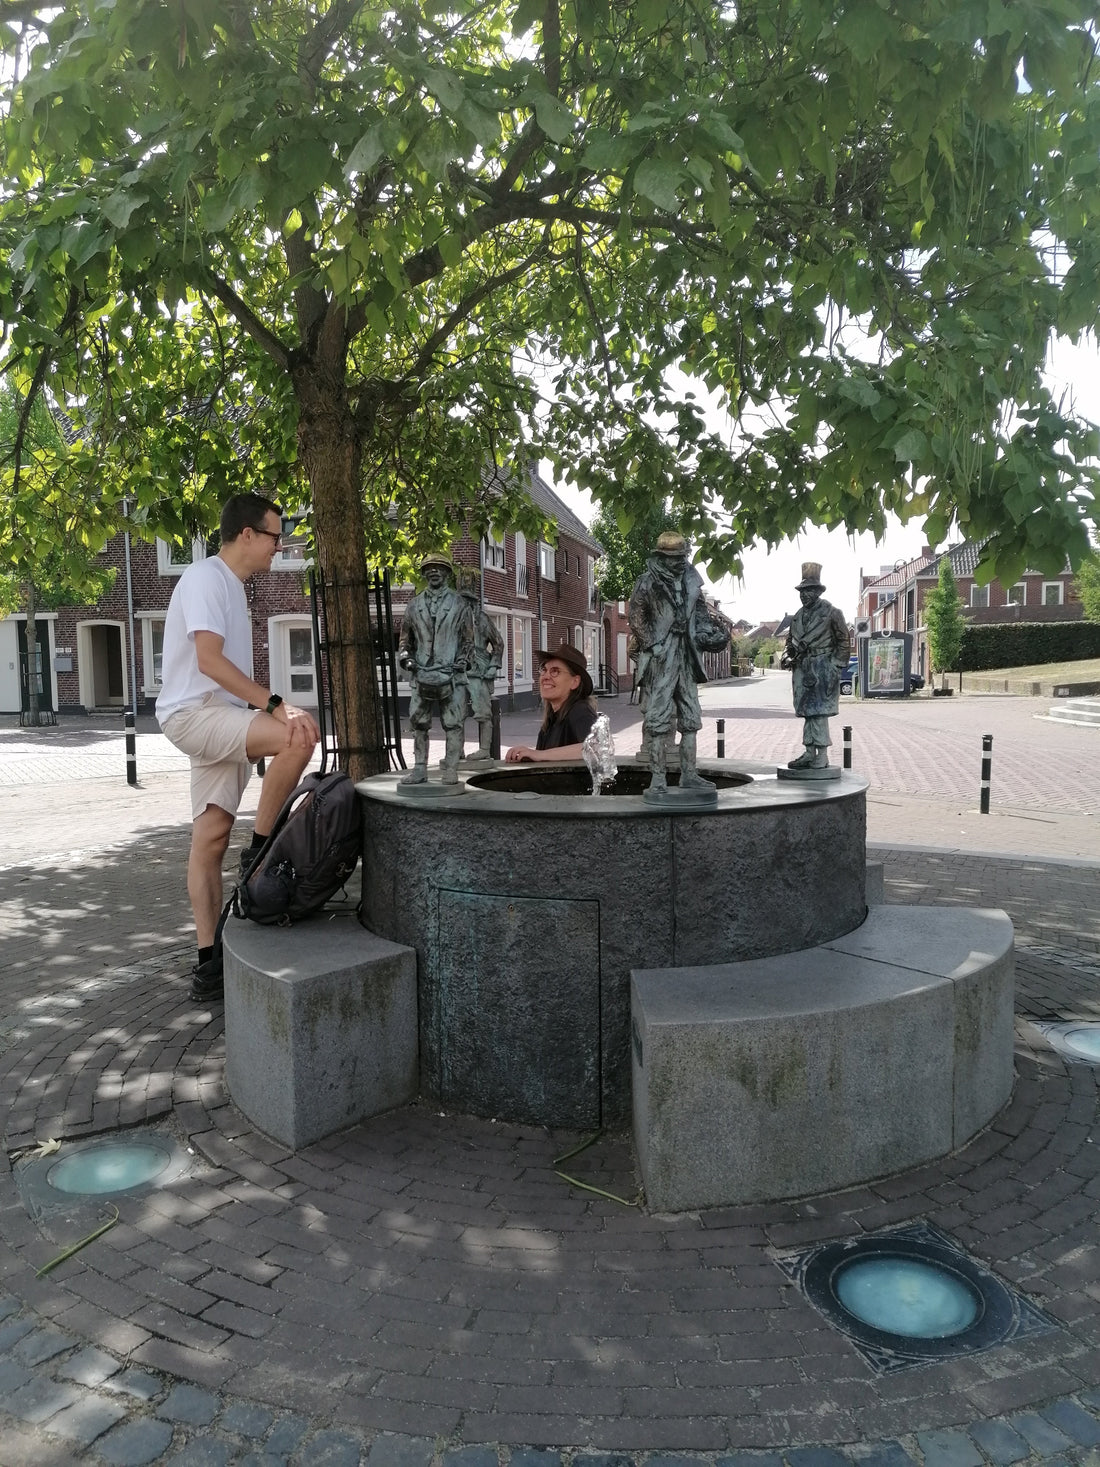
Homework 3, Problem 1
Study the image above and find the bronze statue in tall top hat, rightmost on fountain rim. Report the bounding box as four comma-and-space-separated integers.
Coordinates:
780, 560, 852, 779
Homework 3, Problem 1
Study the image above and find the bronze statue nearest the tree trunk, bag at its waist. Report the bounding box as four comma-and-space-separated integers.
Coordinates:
397, 555, 474, 785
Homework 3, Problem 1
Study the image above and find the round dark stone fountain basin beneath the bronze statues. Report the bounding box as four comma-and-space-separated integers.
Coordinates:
356, 761, 867, 1130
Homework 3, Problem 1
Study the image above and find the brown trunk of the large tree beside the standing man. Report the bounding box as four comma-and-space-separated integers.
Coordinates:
295, 367, 386, 779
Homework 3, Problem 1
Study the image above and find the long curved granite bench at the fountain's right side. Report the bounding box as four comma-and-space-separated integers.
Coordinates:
631, 907, 1015, 1212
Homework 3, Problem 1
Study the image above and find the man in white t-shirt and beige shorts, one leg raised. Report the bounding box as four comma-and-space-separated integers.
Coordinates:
157, 494, 320, 1002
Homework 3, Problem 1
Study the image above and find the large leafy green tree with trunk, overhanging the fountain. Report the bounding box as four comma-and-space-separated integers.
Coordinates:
0, 0, 1100, 775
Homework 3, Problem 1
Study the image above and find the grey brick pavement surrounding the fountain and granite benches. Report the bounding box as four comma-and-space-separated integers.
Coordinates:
0, 689, 1100, 1467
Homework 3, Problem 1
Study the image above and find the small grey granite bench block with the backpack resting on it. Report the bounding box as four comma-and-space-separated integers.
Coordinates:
223, 911, 419, 1149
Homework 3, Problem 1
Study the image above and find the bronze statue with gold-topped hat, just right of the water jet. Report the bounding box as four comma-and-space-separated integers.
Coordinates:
629, 530, 729, 801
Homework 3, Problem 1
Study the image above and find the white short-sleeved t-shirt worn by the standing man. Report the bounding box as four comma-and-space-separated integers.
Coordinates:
157, 556, 252, 728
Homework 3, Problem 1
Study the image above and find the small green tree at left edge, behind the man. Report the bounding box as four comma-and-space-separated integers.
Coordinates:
0, 384, 114, 726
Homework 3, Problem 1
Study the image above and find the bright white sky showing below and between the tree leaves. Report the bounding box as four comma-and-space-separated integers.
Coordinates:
550, 330, 1100, 625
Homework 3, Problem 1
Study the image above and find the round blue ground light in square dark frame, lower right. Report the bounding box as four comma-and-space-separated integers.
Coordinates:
835, 1257, 981, 1339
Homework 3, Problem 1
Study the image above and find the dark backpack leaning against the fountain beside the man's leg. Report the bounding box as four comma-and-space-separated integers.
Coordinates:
230, 770, 362, 924
